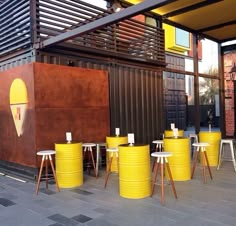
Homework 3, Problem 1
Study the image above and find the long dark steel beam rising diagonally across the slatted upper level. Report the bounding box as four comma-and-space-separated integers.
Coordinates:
35, 0, 176, 49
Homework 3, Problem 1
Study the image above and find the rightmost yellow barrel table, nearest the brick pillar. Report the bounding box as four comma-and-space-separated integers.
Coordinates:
199, 131, 221, 166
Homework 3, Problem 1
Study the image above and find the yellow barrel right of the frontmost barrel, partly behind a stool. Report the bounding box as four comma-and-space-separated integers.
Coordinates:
164, 137, 191, 181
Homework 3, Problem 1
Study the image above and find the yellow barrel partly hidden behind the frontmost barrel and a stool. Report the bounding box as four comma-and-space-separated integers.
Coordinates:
106, 136, 128, 172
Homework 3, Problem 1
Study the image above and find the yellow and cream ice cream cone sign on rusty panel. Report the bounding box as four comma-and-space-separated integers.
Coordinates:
10, 79, 28, 136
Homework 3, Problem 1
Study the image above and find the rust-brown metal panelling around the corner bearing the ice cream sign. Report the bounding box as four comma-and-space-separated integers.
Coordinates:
0, 63, 110, 167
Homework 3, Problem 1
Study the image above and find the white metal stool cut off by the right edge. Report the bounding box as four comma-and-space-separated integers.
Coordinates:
217, 139, 236, 172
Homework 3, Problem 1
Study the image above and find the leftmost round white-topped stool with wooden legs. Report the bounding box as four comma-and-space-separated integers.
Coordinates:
35, 150, 60, 195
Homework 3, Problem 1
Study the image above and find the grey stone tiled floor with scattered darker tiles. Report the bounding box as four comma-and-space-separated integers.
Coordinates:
0, 162, 236, 226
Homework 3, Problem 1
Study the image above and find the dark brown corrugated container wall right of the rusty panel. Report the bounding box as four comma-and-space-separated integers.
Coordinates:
110, 65, 162, 143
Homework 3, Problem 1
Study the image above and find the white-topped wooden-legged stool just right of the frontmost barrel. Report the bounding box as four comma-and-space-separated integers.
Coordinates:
151, 152, 177, 205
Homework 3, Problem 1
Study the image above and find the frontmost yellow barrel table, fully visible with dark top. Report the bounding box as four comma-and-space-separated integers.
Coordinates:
119, 144, 151, 199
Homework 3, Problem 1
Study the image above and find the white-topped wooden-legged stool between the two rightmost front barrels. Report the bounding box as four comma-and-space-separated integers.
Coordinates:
191, 142, 213, 183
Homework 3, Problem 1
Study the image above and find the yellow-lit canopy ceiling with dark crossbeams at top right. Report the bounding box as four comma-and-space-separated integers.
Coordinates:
126, 0, 236, 43
